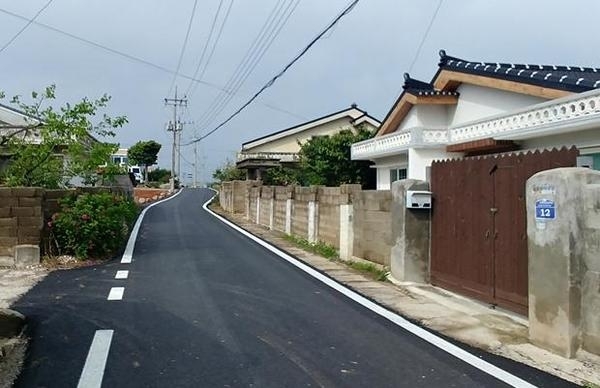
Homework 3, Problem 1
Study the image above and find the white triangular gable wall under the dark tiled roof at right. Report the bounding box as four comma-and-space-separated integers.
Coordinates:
448, 84, 546, 126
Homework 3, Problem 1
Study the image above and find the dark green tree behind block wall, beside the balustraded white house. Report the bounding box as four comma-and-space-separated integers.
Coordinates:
299, 126, 373, 186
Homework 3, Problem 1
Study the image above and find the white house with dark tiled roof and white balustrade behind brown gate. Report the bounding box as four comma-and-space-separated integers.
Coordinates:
352, 50, 600, 190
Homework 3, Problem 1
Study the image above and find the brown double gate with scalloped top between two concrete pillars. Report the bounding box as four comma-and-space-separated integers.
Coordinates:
431, 148, 579, 314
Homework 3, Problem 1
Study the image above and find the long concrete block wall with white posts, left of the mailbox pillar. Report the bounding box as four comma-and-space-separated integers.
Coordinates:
219, 181, 392, 266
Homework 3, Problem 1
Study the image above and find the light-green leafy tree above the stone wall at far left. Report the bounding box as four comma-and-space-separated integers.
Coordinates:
0, 85, 127, 188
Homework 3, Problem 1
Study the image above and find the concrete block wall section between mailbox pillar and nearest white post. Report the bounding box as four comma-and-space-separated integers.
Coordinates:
352, 190, 393, 266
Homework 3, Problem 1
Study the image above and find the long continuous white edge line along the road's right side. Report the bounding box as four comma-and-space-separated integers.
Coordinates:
202, 189, 536, 388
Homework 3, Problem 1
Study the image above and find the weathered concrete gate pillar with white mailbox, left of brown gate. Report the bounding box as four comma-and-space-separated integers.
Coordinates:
390, 179, 435, 283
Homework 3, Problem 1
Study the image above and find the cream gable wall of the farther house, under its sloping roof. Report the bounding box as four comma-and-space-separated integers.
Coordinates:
243, 117, 353, 153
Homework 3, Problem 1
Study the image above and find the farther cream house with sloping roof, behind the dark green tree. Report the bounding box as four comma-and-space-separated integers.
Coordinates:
236, 104, 380, 180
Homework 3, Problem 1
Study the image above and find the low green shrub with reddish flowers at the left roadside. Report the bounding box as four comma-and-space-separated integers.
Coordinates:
48, 193, 138, 259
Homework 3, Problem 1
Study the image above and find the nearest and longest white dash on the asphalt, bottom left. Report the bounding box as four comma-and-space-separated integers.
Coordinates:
77, 330, 114, 388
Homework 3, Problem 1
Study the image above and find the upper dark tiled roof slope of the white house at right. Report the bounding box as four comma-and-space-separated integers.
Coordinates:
439, 50, 600, 93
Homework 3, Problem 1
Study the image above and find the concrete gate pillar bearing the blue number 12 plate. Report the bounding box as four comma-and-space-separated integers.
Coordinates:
526, 168, 600, 357
